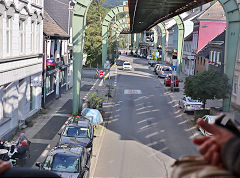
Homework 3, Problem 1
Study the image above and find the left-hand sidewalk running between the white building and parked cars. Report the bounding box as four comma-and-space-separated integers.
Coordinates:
13, 79, 99, 167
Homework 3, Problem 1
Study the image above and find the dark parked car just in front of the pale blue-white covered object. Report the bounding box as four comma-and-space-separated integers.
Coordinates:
59, 120, 94, 155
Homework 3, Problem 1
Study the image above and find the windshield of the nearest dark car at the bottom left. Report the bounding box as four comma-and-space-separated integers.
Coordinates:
51, 154, 79, 173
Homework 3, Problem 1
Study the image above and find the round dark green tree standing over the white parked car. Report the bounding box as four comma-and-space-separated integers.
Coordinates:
184, 70, 231, 108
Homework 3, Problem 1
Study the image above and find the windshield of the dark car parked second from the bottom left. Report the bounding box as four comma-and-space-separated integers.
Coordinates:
63, 126, 90, 138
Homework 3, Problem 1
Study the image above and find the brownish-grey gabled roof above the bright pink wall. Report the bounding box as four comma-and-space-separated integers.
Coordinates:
198, 1, 226, 21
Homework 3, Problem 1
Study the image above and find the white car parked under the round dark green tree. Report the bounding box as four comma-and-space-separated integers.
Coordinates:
179, 96, 203, 112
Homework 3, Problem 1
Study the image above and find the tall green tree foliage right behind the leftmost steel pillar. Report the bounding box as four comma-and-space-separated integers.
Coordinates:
84, 0, 107, 67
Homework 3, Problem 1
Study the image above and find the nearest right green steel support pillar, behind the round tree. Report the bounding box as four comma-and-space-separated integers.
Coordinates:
219, 0, 240, 112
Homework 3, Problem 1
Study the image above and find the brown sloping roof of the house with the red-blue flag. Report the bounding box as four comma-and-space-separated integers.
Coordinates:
43, 10, 69, 39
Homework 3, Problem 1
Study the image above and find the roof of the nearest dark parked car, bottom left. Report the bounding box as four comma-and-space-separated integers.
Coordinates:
50, 145, 84, 156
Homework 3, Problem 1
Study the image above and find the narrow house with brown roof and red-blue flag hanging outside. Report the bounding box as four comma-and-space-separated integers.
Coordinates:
43, 11, 70, 105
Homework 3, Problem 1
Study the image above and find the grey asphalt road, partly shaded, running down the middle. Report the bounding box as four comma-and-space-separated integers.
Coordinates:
94, 56, 197, 177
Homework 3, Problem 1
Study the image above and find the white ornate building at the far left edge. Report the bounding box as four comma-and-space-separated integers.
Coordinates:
0, 0, 43, 137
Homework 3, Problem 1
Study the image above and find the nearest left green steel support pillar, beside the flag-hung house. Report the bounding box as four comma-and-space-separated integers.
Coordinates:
72, 0, 92, 115
